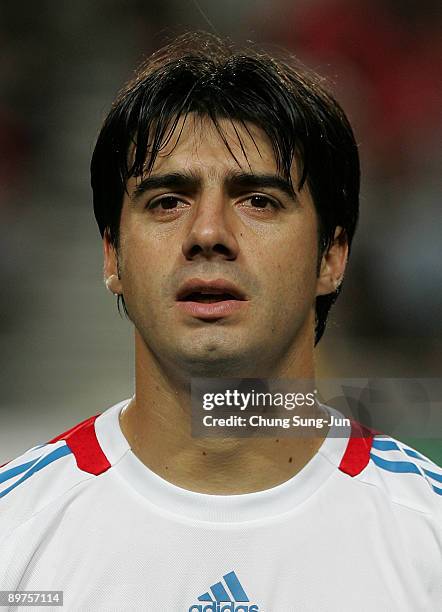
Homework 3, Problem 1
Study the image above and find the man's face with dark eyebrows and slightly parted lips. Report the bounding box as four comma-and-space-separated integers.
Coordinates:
105, 116, 340, 376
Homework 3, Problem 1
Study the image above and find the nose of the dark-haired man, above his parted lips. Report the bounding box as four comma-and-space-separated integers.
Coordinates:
182, 194, 239, 260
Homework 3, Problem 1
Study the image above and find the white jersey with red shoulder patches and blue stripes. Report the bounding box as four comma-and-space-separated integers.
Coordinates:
0, 400, 442, 612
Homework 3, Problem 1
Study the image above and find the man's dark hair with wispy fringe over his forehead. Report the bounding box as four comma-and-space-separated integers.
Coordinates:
91, 33, 359, 343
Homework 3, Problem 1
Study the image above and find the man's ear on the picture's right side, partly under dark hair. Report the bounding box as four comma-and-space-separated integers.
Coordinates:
316, 226, 348, 296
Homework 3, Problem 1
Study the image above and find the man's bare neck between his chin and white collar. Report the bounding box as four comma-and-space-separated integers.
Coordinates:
120, 332, 327, 495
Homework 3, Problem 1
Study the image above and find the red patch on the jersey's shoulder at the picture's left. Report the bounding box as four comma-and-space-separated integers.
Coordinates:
48, 414, 111, 476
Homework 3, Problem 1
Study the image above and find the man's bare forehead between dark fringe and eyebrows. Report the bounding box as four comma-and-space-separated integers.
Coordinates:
138, 113, 277, 178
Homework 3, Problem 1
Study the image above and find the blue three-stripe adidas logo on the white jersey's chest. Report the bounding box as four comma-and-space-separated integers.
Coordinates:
189, 572, 259, 612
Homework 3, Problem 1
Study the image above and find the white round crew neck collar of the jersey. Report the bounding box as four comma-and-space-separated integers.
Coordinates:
95, 399, 350, 523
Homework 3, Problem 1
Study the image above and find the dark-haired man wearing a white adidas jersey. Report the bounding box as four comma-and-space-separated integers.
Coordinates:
0, 36, 442, 612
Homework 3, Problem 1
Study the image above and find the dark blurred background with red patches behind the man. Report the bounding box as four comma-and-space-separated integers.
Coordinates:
0, 0, 442, 464
